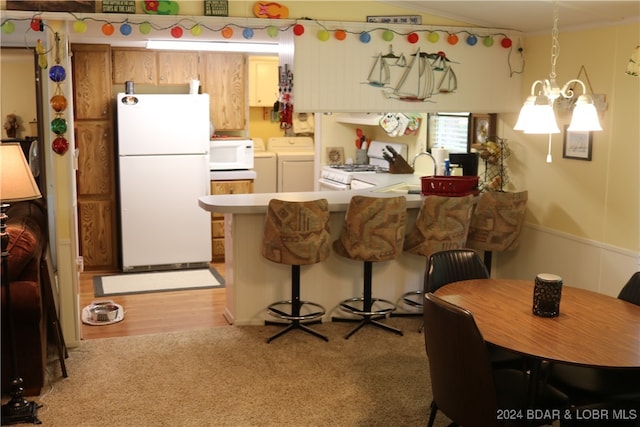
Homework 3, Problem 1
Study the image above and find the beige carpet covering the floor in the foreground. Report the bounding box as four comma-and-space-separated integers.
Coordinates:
30, 318, 456, 427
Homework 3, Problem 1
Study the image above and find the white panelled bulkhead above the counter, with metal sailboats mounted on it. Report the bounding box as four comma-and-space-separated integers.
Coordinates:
292, 21, 523, 113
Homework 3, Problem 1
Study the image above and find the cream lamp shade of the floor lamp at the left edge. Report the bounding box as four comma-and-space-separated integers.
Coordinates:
0, 143, 42, 202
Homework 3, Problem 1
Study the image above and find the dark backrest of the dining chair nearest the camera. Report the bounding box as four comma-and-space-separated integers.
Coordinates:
423, 293, 497, 426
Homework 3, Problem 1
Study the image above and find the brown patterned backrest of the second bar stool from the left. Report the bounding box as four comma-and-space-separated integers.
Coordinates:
333, 196, 407, 262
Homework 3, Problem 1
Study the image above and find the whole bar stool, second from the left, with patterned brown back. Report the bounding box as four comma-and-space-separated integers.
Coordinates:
332, 196, 407, 339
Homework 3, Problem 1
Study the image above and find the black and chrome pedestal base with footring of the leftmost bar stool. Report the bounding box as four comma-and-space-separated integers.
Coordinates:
264, 265, 329, 343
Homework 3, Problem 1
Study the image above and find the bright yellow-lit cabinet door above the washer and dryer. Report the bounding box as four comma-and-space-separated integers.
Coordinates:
249, 56, 279, 107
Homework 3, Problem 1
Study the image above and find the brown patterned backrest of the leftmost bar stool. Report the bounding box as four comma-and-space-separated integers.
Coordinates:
262, 199, 331, 265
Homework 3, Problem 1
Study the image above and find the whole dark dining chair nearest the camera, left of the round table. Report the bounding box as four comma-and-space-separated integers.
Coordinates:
423, 292, 567, 427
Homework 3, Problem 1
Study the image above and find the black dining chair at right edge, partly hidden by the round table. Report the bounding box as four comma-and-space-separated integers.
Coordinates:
545, 271, 640, 416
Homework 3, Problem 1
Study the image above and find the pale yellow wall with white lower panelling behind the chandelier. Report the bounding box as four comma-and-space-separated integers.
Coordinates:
496, 23, 640, 295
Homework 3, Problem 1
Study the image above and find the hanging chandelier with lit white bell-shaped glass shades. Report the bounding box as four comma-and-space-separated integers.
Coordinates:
514, 5, 602, 135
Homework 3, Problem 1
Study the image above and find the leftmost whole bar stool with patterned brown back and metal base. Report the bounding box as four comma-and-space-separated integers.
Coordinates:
262, 199, 330, 342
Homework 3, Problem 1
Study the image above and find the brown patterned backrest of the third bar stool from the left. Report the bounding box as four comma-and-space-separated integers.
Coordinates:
404, 195, 473, 258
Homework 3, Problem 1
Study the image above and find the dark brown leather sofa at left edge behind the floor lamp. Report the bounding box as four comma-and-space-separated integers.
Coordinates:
1, 200, 47, 396
